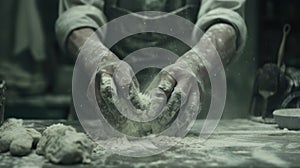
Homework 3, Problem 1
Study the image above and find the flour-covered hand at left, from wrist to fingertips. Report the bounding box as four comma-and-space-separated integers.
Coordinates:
95, 51, 141, 124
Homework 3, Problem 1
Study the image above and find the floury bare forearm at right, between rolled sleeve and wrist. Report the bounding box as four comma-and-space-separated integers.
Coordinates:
178, 23, 237, 74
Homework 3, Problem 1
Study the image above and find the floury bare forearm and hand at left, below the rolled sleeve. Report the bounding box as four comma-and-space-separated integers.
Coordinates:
68, 29, 150, 136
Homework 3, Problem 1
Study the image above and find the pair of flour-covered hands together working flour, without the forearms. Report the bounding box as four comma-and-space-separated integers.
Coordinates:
95, 54, 200, 136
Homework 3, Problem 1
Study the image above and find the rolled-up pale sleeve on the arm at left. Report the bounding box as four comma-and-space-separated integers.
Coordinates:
55, 0, 106, 50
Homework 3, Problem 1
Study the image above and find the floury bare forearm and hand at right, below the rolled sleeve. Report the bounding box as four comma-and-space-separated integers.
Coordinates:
144, 23, 237, 132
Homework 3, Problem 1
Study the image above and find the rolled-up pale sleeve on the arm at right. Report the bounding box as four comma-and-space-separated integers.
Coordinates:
197, 0, 247, 55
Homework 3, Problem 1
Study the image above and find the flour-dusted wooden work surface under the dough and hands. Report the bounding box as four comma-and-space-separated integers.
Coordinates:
0, 120, 300, 168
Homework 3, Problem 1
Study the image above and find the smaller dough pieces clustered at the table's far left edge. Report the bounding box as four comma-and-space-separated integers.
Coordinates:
0, 119, 41, 156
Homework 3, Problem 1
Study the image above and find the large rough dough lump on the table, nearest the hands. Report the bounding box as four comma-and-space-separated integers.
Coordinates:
36, 124, 94, 164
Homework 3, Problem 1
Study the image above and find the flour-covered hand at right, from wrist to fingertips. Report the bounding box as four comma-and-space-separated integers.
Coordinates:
147, 57, 201, 133
